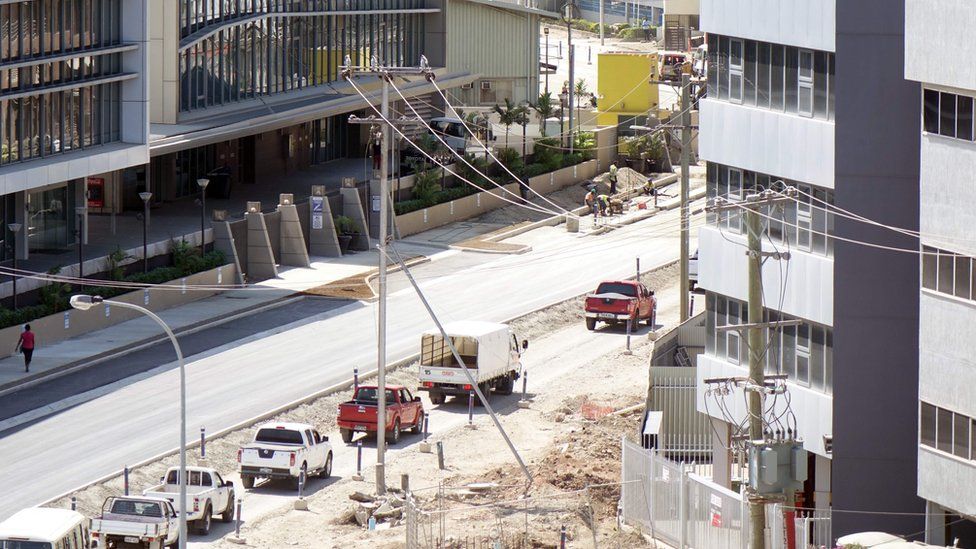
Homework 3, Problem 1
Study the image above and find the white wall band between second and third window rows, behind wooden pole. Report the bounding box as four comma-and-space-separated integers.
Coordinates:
698, 226, 834, 326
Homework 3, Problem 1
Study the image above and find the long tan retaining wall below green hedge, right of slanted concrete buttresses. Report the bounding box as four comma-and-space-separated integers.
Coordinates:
396, 160, 597, 238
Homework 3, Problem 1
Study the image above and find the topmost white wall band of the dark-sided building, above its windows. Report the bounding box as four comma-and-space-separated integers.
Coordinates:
701, 0, 832, 51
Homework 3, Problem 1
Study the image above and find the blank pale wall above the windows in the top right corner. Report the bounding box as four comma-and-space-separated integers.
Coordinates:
905, 0, 976, 90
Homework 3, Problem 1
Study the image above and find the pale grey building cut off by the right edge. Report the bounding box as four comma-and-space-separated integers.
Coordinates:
905, 0, 976, 547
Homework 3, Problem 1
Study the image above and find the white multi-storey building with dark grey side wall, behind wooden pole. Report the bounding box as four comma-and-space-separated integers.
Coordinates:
698, 0, 921, 535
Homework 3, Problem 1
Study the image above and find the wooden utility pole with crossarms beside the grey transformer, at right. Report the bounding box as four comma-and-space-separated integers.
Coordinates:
708, 188, 799, 549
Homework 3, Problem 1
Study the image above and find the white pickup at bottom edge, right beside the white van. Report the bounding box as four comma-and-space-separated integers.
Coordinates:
91, 496, 180, 549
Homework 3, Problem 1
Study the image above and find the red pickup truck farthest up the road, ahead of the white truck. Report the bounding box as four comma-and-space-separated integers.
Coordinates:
585, 280, 657, 330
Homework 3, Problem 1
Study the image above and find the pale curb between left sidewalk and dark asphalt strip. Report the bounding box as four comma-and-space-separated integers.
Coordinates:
0, 290, 306, 396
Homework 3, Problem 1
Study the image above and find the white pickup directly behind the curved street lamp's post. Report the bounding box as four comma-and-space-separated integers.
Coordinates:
142, 467, 234, 535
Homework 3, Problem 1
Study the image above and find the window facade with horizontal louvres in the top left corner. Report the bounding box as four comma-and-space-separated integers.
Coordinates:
0, 0, 132, 165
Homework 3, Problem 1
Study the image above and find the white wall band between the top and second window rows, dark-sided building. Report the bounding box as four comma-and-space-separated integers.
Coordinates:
698, 99, 834, 189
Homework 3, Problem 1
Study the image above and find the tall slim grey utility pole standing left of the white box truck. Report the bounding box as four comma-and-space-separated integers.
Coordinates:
342, 55, 430, 495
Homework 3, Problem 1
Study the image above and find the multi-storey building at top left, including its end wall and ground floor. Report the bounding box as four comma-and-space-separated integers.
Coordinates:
0, 0, 149, 259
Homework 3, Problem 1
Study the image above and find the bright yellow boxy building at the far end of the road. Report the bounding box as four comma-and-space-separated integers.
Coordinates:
597, 52, 659, 127
